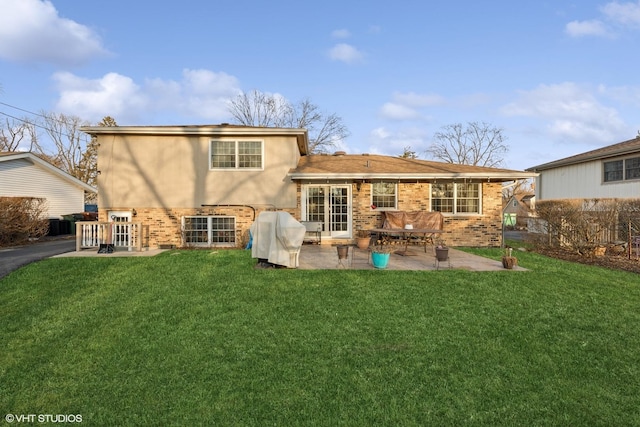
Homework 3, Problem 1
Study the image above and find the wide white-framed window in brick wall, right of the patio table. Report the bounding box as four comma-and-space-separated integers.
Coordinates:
431, 183, 481, 214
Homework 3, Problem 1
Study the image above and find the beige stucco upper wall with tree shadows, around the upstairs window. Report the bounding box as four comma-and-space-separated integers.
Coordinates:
98, 135, 299, 208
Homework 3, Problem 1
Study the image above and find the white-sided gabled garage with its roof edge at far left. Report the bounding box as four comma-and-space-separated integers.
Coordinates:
0, 152, 96, 219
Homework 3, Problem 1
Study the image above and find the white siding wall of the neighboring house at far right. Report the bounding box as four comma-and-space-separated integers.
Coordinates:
535, 161, 640, 200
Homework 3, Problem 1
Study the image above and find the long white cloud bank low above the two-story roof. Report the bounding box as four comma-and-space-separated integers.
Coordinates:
54, 69, 240, 124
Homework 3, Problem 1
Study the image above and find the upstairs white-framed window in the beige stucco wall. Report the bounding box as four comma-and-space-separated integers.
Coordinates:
210, 140, 264, 169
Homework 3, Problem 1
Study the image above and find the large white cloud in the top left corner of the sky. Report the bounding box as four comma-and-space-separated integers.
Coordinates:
0, 0, 107, 65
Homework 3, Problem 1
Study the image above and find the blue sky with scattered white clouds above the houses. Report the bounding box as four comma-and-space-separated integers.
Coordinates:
0, 0, 640, 170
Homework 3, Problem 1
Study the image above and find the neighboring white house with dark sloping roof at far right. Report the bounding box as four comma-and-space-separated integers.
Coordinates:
526, 137, 640, 201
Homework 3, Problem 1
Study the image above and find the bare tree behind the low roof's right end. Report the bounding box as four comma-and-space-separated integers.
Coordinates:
427, 122, 509, 167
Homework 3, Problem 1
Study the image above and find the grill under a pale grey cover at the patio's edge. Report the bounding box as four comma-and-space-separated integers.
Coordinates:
250, 211, 307, 268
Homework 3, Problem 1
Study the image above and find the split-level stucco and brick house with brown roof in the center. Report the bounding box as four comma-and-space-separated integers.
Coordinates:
82, 124, 535, 246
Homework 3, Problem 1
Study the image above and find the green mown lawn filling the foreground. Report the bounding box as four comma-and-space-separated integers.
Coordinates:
0, 249, 640, 426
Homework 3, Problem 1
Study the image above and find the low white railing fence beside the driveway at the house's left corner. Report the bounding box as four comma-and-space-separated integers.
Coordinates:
76, 221, 149, 251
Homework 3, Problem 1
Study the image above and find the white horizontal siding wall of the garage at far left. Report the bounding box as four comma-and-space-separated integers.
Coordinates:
0, 159, 84, 218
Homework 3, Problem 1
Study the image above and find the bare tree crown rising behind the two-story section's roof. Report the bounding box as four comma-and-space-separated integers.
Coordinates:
229, 90, 349, 153
